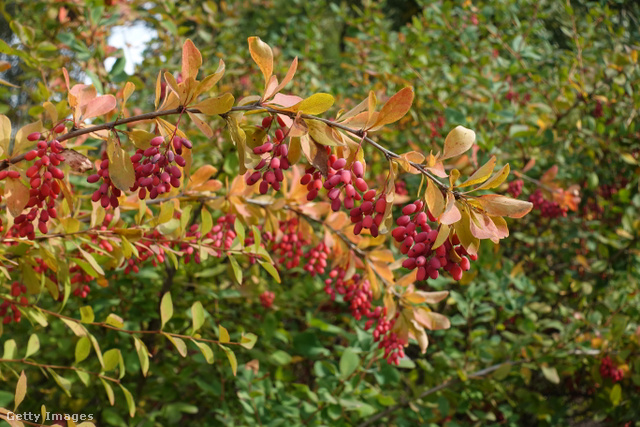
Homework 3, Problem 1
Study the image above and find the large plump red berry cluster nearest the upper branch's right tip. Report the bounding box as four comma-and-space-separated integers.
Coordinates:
391, 200, 478, 281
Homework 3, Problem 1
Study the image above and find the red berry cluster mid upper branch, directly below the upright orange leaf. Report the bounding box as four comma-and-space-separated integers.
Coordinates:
245, 116, 289, 194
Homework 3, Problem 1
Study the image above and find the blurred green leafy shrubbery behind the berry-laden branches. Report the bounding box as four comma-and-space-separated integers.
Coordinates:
0, 0, 640, 426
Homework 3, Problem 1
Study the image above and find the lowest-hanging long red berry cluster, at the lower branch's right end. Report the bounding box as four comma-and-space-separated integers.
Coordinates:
324, 268, 405, 365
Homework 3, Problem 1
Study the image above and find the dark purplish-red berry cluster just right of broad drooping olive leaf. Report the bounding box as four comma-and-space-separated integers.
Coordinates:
131, 136, 193, 200
